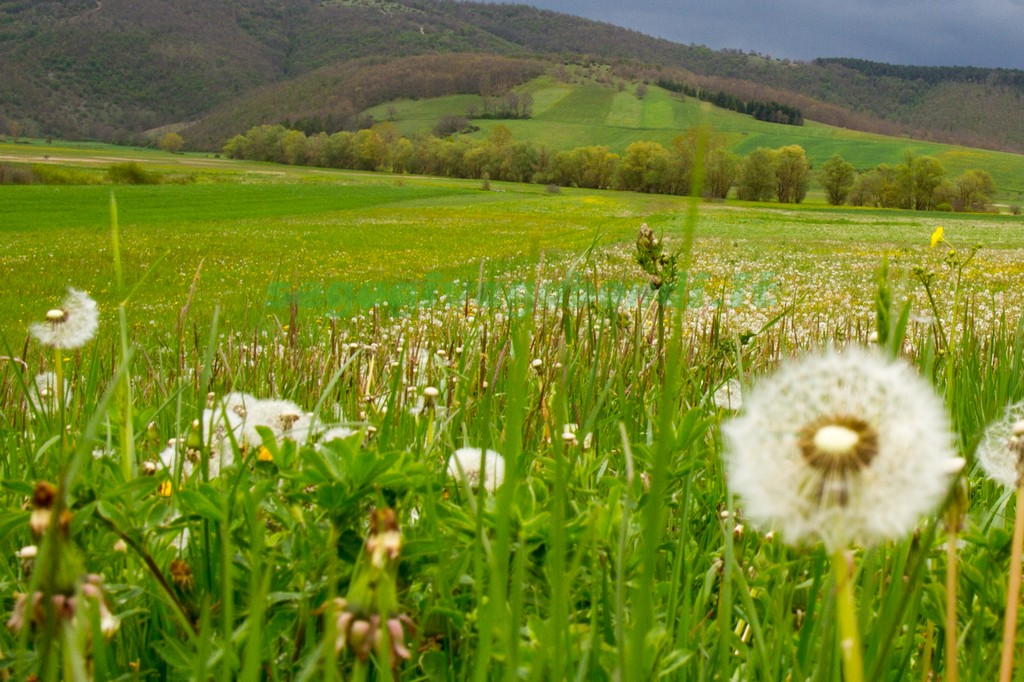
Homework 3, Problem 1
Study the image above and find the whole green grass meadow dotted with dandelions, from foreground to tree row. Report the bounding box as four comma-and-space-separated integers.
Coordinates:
6, 146, 1024, 681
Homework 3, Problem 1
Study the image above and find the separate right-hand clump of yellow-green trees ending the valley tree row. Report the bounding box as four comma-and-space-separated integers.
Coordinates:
818, 152, 995, 212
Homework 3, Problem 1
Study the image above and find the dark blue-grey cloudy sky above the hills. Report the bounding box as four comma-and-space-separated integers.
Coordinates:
485, 0, 1024, 69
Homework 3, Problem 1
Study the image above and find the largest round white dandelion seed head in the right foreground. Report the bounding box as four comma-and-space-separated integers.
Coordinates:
722, 348, 964, 550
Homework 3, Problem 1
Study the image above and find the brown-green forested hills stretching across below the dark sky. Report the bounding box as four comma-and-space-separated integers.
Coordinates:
0, 0, 1024, 152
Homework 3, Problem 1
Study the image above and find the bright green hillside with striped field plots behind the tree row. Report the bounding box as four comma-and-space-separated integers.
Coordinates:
365, 76, 1024, 201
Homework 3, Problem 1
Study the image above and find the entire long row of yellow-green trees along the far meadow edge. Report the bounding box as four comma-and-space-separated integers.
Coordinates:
223, 119, 994, 210
